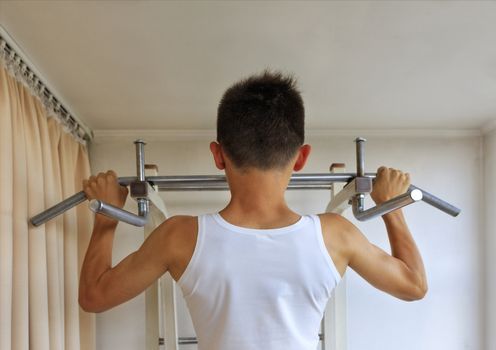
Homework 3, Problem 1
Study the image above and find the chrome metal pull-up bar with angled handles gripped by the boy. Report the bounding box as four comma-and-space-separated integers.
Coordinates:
30, 138, 460, 226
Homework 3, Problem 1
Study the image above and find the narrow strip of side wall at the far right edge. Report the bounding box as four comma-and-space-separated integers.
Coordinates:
483, 129, 496, 350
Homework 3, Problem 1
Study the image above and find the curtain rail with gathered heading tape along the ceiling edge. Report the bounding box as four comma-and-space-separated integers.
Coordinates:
0, 27, 93, 144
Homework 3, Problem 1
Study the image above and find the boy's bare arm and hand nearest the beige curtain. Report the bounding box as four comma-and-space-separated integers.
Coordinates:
79, 171, 196, 312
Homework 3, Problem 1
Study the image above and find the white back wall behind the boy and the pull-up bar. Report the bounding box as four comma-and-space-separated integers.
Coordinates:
90, 134, 482, 350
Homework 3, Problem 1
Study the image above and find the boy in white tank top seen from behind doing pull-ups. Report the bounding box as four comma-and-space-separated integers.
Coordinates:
79, 72, 427, 350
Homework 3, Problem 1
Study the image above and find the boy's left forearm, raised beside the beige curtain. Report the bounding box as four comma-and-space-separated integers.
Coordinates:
79, 215, 117, 304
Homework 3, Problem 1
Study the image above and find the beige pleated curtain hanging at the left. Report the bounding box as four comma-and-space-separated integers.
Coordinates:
0, 63, 95, 350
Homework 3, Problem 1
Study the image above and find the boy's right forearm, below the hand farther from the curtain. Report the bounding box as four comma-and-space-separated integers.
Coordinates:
383, 210, 427, 290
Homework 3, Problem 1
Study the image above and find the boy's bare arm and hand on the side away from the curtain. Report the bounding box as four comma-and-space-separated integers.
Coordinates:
324, 168, 427, 301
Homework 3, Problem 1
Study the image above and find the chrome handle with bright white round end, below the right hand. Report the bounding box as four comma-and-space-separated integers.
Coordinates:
352, 188, 422, 221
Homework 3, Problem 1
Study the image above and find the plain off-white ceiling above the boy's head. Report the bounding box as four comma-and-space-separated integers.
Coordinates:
0, 0, 496, 130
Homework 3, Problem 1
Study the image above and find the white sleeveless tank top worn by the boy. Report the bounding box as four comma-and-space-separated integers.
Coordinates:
178, 214, 341, 350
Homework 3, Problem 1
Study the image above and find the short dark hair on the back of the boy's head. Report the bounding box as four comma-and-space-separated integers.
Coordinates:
217, 70, 305, 170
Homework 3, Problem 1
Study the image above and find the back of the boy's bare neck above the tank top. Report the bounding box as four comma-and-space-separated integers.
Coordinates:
220, 170, 300, 228
